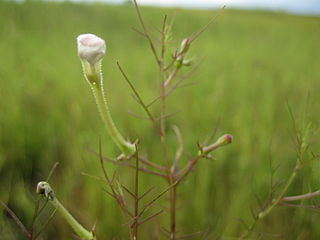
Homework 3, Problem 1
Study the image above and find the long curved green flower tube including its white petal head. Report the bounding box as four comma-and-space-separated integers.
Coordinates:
77, 34, 136, 156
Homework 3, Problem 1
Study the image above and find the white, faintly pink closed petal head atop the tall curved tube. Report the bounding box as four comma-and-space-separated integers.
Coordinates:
77, 33, 106, 65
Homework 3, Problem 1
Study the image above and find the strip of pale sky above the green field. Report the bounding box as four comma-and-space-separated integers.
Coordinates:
53, 0, 320, 15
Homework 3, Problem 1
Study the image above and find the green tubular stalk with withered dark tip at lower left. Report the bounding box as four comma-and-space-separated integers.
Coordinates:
37, 182, 96, 240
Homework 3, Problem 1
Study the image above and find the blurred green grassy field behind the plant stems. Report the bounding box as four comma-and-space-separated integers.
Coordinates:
0, 2, 320, 240
